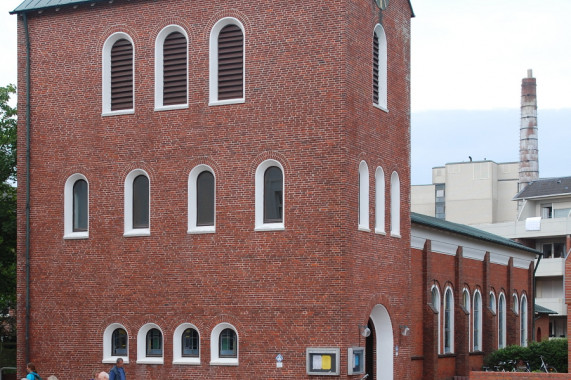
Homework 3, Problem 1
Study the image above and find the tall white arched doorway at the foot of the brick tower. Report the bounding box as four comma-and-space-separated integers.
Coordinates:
365, 305, 394, 380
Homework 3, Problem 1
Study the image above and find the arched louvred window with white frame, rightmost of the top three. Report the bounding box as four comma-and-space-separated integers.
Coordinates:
210, 17, 245, 105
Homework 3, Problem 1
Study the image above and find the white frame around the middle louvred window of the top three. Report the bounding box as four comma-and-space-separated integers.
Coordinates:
155, 25, 189, 111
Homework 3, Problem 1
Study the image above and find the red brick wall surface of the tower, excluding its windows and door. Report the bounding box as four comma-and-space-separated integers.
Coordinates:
18, 0, 411, 379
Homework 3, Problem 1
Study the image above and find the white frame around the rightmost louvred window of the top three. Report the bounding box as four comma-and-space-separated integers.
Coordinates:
208, 17, 246, 106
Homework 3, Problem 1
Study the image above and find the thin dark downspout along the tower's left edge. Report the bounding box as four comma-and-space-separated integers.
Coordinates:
22, 12, 31, 363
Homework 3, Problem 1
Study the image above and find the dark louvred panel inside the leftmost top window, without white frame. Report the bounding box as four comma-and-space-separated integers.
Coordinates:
111, 38, 133, 111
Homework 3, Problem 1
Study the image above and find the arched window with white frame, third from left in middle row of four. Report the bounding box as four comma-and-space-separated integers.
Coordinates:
188, 165, 216, 233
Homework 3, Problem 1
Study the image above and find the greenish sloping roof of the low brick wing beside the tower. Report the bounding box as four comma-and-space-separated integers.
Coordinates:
410, 212, 542, 255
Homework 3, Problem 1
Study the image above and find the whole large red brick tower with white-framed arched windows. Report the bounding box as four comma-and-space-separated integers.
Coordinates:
15, 0, 412, 379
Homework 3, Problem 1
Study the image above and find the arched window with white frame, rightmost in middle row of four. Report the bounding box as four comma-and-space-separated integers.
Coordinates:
256, 160, 285, 231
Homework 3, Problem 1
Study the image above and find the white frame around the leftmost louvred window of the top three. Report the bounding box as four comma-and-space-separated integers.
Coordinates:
101, 32, 136, 116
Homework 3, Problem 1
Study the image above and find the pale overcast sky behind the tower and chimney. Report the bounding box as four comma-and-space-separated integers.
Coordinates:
0, 0, 571, 184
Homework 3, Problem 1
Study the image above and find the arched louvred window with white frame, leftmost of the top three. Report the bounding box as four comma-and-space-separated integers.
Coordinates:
102, 32, 135, 115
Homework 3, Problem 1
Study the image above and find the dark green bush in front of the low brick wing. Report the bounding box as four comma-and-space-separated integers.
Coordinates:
484, 339, 568, 372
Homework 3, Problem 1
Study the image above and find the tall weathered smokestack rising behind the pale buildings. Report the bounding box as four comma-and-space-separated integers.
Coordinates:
518, 69, 539, 191
